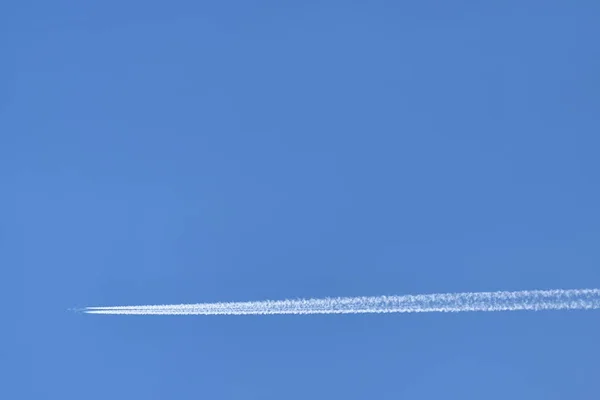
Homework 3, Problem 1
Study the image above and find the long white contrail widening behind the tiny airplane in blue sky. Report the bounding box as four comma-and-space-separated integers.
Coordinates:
83, 289, 600, 315
